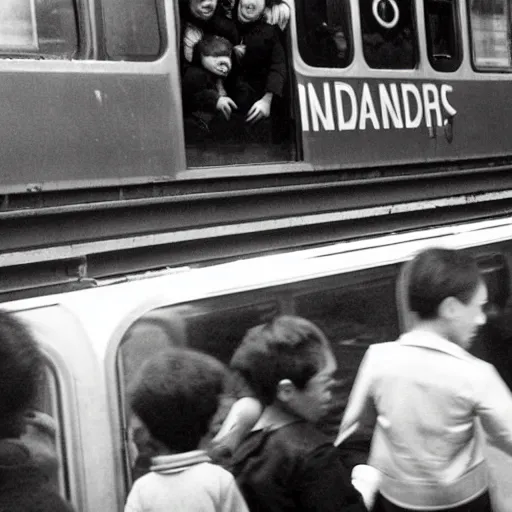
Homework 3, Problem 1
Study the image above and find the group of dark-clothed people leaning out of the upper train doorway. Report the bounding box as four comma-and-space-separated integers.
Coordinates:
180, 0, 290, 142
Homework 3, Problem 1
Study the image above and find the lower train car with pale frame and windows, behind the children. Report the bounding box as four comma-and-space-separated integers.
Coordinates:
8, 217, 512, 512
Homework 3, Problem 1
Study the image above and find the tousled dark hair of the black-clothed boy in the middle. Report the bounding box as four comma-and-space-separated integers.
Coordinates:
231, 316, 328, 404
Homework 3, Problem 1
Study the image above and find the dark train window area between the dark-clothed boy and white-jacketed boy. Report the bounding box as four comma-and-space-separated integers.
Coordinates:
295, 267, 399, 443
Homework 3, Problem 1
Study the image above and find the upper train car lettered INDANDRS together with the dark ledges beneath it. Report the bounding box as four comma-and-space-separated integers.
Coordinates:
0, 0, 512, 298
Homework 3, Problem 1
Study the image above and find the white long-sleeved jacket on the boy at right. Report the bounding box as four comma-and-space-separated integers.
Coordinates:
336, 330, 512, 510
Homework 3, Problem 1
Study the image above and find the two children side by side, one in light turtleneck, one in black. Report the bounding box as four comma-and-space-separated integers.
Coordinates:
125, 316, 367, 512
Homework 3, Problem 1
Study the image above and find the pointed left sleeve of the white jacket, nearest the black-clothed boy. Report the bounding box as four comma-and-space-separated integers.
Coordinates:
334, 347, 377, 446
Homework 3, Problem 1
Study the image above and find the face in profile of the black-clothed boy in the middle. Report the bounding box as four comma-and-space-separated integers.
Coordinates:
286, 347, 337, 423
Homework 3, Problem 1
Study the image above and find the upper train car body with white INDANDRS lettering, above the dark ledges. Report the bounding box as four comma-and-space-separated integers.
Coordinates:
0, 0, 512, 190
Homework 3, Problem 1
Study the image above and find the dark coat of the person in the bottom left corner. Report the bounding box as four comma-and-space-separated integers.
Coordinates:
0, 440, 73, 512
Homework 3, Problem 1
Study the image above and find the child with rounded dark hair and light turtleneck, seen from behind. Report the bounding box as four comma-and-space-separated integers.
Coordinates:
125, 349, 251, 512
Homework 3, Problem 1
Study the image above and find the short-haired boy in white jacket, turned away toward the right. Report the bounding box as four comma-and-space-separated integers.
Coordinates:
337, 248, 512, 512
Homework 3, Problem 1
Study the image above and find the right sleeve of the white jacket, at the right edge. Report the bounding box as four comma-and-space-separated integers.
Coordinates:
475, 363, 512, 455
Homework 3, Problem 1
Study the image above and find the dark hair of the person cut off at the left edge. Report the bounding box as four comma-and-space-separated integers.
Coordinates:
0, 310, 43, 439
